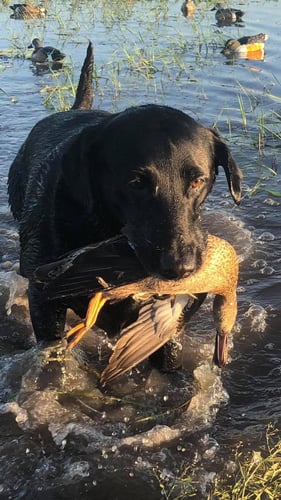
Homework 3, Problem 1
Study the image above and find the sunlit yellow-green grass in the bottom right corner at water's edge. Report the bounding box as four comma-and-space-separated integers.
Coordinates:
153, 426, 281, 500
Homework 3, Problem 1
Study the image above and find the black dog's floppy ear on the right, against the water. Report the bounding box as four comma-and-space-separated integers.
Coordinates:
210, 129, 243, 205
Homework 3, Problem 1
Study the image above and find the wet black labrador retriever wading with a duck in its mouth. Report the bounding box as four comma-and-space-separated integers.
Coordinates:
8, 44, 242, 346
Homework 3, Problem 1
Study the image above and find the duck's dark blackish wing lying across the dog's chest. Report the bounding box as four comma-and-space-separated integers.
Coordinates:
34, 236, 146, 300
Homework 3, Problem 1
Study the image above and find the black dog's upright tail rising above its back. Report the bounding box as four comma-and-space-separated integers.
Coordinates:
71, 42, 94, 109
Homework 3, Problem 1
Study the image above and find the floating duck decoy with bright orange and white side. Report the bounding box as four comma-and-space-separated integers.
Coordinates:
222, 33, 268, 59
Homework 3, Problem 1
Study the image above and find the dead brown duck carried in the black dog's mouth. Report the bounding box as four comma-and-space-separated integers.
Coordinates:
35, 235, 239, 384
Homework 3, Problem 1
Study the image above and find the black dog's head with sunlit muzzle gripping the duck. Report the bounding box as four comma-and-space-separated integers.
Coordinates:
62, 105, 242, 278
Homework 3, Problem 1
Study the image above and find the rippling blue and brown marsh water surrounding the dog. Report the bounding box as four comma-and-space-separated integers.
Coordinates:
0, 0, 281, 500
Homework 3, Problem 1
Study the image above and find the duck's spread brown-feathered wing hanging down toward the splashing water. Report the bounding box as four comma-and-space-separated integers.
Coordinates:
101, 295, 189, 385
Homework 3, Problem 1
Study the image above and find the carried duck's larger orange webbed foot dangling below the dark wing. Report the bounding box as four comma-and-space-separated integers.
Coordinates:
66, 292, 108, 350
